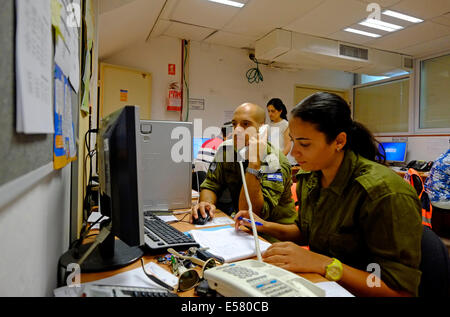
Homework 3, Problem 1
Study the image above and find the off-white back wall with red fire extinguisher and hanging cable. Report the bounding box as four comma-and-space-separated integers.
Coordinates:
104, 37, 353, 128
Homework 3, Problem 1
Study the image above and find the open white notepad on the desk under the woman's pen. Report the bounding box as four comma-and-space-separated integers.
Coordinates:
190, 227, 270, 262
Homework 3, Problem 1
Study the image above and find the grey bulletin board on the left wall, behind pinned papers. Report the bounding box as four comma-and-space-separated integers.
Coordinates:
0, 0, 79, 188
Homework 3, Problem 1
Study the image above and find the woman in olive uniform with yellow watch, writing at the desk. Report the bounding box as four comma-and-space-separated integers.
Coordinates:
235, 93, 423, 296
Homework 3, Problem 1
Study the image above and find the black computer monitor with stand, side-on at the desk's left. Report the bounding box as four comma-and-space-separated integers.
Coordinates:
60, 106, 144, 272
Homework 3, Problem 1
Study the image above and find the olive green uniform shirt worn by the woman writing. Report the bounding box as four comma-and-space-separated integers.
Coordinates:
296, 150, 423, 296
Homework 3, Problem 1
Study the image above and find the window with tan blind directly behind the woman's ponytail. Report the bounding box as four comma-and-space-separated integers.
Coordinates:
353, 76, 410, 134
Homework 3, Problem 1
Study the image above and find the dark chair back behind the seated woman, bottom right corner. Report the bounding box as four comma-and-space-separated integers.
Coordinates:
419, 226, 450, 297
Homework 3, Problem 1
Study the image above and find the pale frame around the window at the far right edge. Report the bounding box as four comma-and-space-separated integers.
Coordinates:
413, 50, 450, 135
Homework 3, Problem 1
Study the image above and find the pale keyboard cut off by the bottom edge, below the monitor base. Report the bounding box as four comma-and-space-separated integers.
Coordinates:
83, 284, 178, 297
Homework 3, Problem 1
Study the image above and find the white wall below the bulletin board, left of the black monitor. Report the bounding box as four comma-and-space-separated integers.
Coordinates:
0, 165, 71, 297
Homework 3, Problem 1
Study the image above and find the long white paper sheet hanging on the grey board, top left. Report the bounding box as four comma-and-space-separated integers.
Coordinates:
16, 0, 54, 134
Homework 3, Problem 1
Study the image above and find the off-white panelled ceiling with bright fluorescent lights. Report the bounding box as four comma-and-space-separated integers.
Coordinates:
99, 0, 450, 59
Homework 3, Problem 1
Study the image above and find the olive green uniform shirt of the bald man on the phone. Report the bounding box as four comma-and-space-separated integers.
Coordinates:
200, 143, 297, 224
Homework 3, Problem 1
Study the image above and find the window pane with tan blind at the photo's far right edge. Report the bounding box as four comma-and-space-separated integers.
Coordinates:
419, 55, 450, 129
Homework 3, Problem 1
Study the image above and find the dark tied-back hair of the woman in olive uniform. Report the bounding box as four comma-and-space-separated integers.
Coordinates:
291, 92, 386, 163
